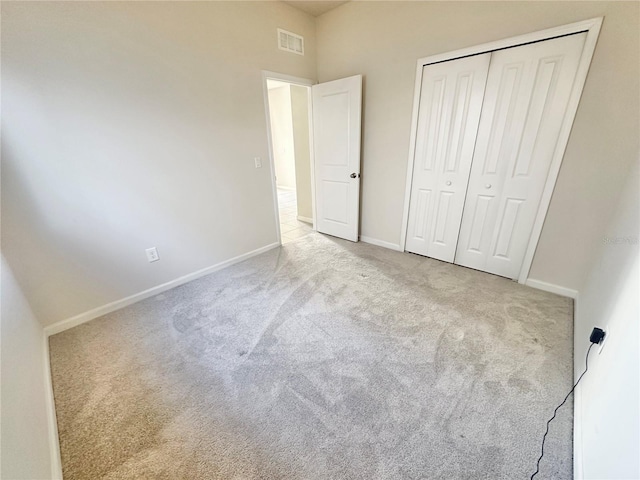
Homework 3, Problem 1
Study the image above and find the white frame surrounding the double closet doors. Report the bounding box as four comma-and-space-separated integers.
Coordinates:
400, 17, 604, 283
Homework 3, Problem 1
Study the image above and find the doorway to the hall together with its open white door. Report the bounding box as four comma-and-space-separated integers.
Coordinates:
264, 71, 362, 243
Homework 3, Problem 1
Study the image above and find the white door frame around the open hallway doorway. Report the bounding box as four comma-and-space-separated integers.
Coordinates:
262, 70, 316, 245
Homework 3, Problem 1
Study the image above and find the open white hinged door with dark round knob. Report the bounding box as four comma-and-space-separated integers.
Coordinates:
311, 75, 362, 242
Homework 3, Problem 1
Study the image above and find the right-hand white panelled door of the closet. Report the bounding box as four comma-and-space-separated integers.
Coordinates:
455, 33, 586, 278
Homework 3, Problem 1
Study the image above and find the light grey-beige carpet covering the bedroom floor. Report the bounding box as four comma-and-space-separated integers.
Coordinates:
50, 233, 573, 479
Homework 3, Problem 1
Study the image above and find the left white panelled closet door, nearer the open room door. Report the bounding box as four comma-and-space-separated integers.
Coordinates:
405, 53, 491, 262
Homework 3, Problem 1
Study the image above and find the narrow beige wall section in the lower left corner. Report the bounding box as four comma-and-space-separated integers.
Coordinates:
0, 256, 52, 479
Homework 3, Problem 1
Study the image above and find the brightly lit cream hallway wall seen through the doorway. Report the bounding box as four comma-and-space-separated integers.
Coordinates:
267, 85, 296, 190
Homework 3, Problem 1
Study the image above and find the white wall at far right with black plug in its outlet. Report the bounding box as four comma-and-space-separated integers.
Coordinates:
574, 162, 640, 479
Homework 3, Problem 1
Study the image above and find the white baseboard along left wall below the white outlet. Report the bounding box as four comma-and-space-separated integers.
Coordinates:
44, 242, 280, 337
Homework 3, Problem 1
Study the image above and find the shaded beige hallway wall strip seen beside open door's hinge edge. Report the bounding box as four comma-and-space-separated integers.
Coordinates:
291, 85, 313, 219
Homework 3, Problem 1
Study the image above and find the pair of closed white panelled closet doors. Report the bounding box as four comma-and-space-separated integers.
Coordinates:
405, 33, 587, 279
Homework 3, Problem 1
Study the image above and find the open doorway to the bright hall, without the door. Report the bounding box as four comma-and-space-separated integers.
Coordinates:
265, 77, 314, 244
